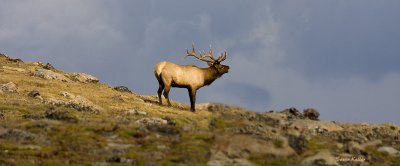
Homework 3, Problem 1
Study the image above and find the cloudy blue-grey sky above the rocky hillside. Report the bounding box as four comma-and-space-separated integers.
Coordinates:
0, 0, 400, 124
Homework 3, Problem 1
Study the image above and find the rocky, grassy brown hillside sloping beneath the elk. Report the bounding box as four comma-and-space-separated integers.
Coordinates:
0, 54, 400, 166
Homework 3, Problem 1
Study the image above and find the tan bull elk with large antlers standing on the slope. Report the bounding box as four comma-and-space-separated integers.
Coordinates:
154, 44, 229, 112
